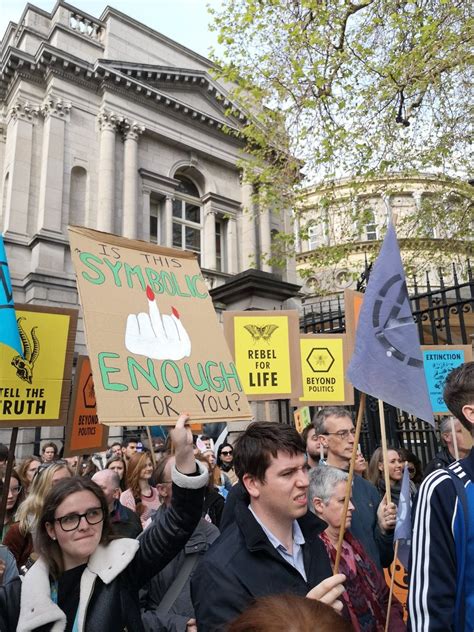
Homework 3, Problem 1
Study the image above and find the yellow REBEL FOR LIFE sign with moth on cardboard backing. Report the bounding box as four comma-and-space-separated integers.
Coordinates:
223, 310, 302, 400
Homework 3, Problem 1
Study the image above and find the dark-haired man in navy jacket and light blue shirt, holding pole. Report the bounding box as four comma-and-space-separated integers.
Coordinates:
191, 422, 345, 632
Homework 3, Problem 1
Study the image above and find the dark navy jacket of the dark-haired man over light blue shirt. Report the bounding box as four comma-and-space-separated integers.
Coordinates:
191, 501, 332, 632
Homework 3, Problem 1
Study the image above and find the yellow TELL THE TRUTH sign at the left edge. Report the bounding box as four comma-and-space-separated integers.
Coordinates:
0, 305, 77, 428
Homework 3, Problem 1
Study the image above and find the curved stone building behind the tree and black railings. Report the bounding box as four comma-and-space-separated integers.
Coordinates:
296, 174, 474, 302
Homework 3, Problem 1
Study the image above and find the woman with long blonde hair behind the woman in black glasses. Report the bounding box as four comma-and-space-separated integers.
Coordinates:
4, 461, 72, 569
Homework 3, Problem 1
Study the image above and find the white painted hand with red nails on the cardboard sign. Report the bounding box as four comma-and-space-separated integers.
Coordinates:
125, 286, 191, 360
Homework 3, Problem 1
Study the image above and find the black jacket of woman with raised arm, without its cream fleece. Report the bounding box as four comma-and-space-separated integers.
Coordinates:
0, 469, 207, 632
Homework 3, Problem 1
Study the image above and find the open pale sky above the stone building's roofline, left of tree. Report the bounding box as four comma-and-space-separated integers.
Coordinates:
0, 0, 222, 57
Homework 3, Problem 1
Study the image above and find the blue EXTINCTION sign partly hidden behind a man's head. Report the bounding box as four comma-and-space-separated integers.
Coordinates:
421, 345, 472, 415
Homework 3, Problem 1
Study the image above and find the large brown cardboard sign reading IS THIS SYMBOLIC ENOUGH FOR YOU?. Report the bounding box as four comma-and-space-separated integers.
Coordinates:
69, 227, 251, 426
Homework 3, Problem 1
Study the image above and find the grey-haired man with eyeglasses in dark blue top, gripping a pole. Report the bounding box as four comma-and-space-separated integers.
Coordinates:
313, 406, 397, 568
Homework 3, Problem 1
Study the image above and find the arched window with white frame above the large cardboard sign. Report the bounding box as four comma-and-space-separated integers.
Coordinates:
173, 176, 202, 259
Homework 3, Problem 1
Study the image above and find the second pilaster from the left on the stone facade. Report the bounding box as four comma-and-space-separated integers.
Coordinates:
37, 96, 71, 233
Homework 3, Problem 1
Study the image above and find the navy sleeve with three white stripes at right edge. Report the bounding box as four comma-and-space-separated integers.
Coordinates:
408, 470, 457, 632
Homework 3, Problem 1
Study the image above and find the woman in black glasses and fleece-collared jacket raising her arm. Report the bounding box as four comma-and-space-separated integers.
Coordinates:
0, 415, 207, 632
